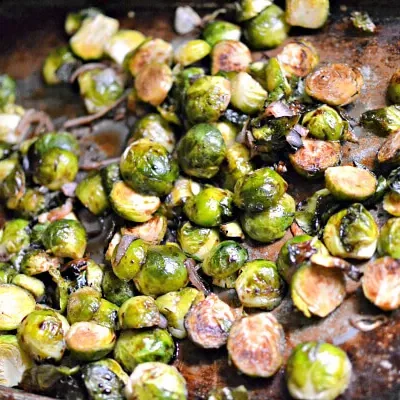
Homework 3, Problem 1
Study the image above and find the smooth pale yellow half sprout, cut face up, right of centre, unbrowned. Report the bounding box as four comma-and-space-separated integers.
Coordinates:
325, 165, 378, 201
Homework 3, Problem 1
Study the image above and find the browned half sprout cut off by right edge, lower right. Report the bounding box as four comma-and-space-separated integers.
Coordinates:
362, 257, 400, 311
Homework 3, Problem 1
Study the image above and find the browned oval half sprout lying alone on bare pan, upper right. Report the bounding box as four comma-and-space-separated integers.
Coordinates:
305, 64, 364, 106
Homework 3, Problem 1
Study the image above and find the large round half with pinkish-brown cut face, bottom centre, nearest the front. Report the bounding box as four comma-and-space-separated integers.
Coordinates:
227, 313, 285, 378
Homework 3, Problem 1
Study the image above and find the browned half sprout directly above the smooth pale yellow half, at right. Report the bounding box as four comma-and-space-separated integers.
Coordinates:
289, 139, 341, 179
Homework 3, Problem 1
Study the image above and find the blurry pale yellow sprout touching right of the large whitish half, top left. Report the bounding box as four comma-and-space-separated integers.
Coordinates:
104, 29, 146, 65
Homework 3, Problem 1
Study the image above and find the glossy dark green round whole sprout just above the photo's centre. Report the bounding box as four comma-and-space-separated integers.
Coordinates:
177, 124, 226, 179
